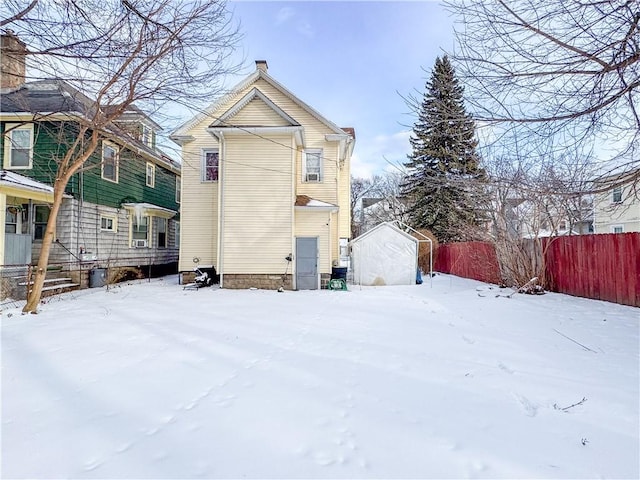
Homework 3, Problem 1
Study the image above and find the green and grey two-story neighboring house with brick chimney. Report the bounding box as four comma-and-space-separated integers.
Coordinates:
0, 34, 180, 296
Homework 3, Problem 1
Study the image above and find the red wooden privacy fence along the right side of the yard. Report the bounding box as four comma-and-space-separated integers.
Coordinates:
434, 233, 640, 307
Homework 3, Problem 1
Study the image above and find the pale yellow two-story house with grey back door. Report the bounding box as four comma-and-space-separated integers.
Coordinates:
171, 60, 355, 290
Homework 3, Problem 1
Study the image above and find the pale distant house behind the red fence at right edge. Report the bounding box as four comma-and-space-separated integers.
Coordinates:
594, 170, 640, 233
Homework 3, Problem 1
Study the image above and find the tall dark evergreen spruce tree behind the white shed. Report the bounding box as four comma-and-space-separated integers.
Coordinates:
403, 56, 485, 243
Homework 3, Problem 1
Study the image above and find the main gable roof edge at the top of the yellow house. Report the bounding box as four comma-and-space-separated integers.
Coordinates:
169, 63, 351, 141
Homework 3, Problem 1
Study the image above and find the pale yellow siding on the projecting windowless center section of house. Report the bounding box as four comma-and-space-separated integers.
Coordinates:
222, 134, 295, 274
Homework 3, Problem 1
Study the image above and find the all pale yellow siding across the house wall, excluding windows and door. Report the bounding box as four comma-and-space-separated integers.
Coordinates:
178, 80, 350, 275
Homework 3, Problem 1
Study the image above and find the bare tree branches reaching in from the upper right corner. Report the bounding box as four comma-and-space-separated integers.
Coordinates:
446, 0, 640, 185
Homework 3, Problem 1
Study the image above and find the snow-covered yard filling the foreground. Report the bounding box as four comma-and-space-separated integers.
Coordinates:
1, 275, 640, 478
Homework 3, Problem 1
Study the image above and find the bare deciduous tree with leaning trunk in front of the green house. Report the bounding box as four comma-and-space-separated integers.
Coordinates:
3, 0, 238, 312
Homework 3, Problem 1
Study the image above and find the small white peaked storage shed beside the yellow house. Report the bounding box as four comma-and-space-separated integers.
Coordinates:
350, 222, 419, 285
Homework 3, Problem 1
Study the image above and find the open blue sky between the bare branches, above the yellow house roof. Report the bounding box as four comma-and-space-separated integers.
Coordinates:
229, 0, 453, 177
